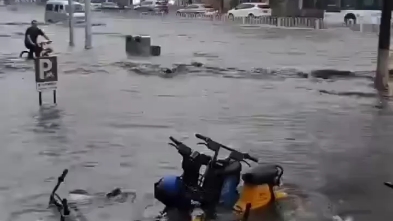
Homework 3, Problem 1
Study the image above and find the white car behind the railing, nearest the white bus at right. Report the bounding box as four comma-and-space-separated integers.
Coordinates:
228, 2, 272, 20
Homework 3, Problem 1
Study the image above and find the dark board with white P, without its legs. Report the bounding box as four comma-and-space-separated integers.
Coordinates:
35, 56, 57, 83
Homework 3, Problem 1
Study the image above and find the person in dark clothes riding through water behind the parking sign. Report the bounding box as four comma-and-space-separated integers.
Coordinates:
25, 20, 49, 59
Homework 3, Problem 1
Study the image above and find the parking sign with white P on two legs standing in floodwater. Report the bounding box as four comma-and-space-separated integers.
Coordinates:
34, 56, 58, 106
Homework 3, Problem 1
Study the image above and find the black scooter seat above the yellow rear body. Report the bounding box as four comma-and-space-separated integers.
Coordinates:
242, 165, 279, 185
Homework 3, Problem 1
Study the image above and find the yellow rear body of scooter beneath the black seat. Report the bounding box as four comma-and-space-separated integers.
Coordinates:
234, 184, 287, 213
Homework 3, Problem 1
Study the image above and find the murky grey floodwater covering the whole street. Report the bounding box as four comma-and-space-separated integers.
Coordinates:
0, 4, 393, 221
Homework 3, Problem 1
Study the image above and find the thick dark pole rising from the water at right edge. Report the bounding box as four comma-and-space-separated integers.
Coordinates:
374, 0, 393, 96
